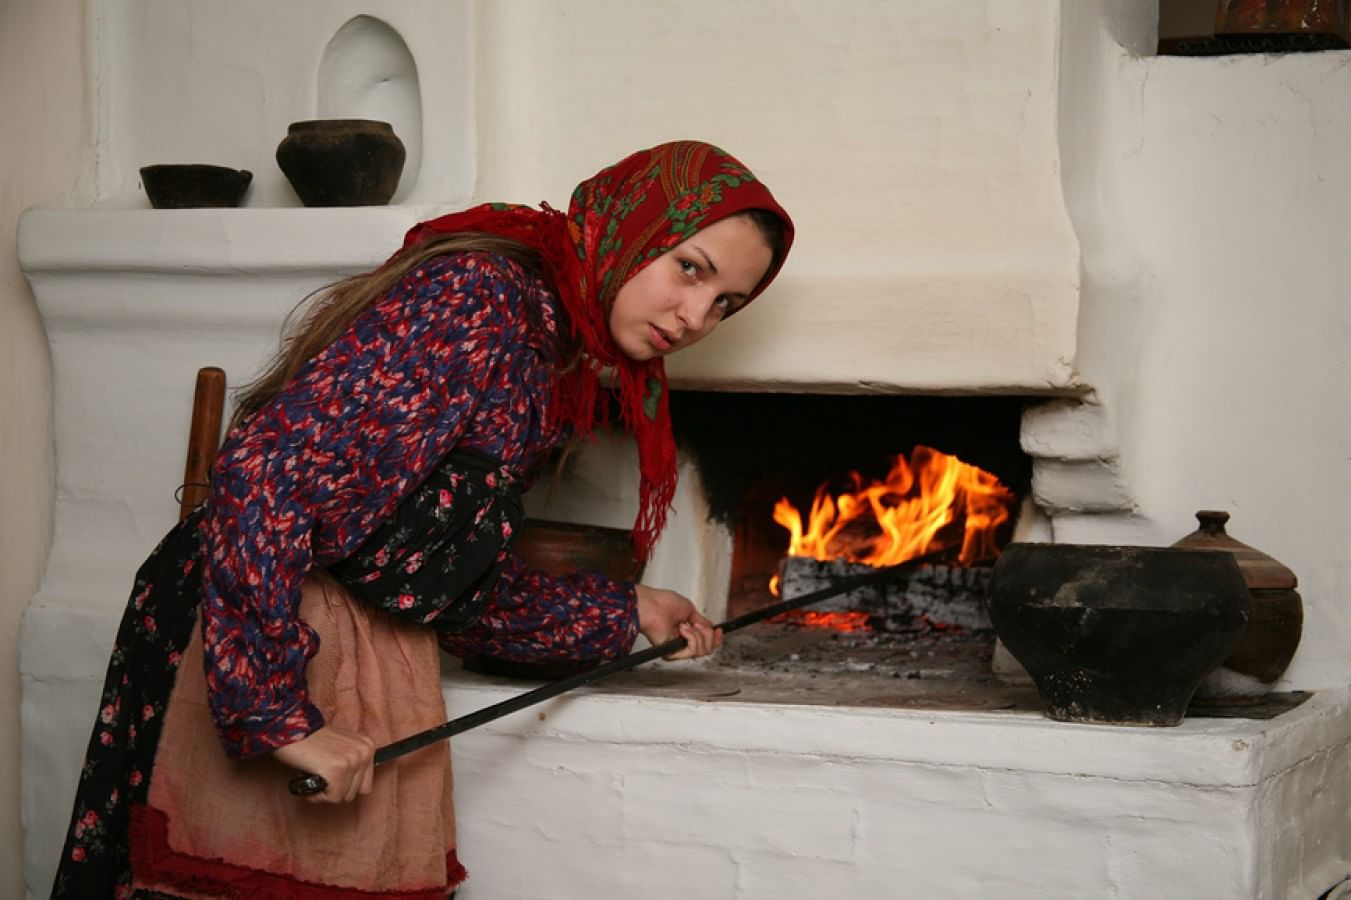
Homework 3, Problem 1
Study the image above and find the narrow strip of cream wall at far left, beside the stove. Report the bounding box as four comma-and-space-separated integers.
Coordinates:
0, 0, 92, 897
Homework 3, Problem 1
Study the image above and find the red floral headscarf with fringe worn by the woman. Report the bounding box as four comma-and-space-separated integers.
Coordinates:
404, 141, 793, 559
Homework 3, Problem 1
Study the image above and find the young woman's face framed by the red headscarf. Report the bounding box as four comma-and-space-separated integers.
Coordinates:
609, 215, 773, 361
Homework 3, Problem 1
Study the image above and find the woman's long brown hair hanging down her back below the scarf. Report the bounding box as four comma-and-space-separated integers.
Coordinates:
230, 231, 562, 428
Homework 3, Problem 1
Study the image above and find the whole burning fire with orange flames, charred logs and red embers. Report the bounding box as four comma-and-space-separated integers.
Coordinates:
770, 446, 1015, 632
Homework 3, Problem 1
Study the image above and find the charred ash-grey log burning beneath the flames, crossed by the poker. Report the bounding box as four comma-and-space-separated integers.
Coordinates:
781, 557, 992, 632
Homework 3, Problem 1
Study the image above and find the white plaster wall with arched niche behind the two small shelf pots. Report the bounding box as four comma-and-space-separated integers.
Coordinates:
91, 0, 474, 207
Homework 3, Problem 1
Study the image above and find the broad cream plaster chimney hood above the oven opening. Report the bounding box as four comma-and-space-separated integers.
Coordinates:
477, 0, 1078, 392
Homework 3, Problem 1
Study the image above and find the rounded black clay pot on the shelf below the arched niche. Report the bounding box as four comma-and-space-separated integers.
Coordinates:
277, 119, 407, 207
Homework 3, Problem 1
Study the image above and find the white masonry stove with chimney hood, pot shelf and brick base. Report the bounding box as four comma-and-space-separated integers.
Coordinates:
20, 0, 1351, 900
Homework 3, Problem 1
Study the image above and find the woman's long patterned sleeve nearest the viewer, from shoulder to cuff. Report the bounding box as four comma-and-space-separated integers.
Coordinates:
203, 255, 527, 757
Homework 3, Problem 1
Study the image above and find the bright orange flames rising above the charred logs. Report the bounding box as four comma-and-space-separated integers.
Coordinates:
771, 446, 1013, 575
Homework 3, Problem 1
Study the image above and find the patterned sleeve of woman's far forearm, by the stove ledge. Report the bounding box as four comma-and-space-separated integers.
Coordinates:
438, 553, 638, 662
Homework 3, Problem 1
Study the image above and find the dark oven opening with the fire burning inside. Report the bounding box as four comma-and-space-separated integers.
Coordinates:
671, 391, 1032, 705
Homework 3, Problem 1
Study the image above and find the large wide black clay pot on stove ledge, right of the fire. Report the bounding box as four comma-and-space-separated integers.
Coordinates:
990, 543, 1250, 726
